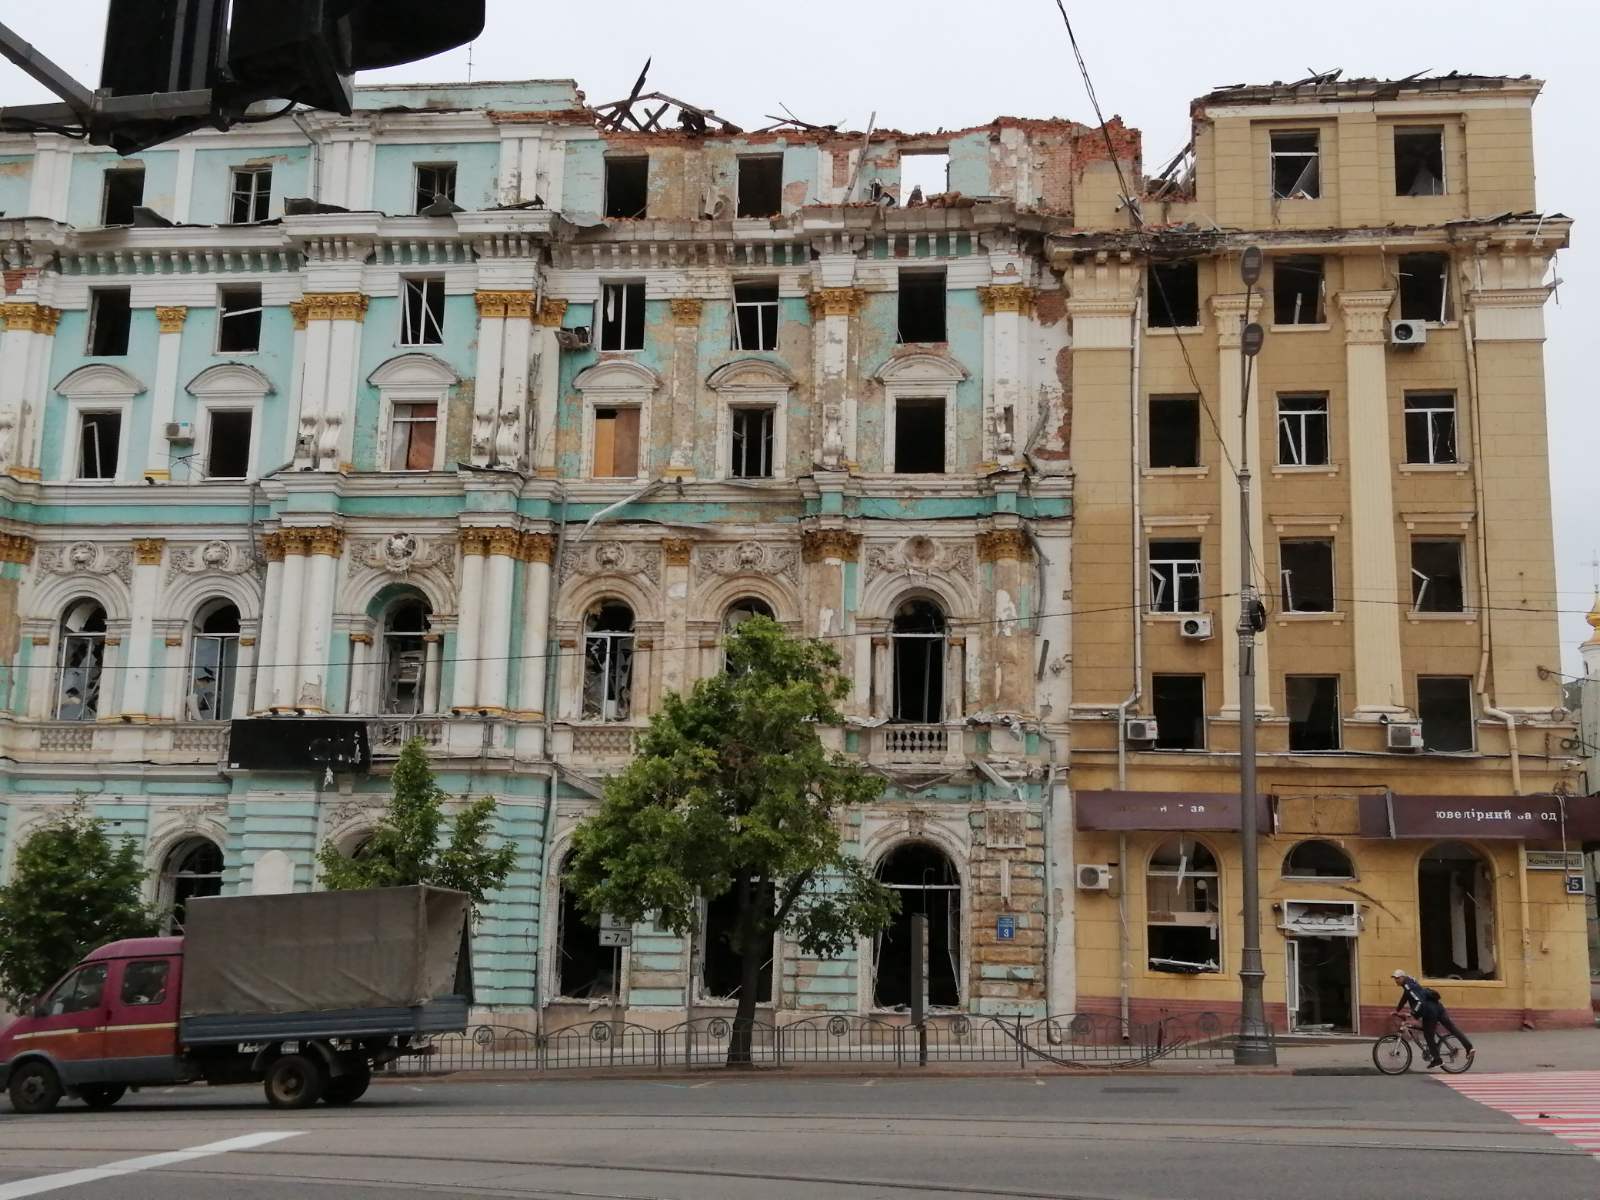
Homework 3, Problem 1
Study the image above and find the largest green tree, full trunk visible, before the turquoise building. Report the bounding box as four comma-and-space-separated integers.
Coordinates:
568, 618, 899, 1064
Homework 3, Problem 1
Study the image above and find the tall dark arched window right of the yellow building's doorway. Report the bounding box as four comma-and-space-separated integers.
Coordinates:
1416, 842, 1496, 979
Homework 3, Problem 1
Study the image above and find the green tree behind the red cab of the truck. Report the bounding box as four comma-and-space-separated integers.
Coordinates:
0, 811, 158, 1008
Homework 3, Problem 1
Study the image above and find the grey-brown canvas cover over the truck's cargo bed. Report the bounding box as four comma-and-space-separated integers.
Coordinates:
182, 886, 470, 1018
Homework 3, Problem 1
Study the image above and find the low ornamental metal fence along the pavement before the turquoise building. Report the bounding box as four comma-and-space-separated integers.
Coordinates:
386, 1013, 1260, 1075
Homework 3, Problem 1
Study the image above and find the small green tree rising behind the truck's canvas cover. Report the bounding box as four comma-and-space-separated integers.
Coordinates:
317, 738, 517, 906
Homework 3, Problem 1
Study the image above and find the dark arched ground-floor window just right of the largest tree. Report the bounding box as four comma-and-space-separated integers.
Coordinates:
872, 842, 962, 1010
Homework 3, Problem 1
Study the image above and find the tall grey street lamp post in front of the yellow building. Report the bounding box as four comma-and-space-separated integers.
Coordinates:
1234, 246, 1278, 1066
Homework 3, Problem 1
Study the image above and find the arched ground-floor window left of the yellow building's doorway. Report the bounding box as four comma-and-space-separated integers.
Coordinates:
1144, 837, 1222, 974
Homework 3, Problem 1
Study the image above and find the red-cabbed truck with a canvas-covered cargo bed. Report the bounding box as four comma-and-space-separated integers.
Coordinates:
0, 886, 472, 1114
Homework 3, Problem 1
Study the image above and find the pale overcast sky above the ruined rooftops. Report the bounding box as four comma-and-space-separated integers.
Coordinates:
0, 0, 1600, 670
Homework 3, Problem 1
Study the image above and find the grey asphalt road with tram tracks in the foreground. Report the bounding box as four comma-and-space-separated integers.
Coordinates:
0, 1075, 1600, 1200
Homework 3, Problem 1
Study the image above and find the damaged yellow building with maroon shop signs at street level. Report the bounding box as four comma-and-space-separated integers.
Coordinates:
1050, 77, 1600, 1032
